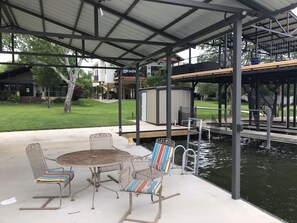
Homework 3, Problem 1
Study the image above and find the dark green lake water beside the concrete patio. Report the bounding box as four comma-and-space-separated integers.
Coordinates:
143, 137, 297, 223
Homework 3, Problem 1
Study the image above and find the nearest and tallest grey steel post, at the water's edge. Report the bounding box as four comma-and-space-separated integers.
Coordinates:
232, 15, 242, 199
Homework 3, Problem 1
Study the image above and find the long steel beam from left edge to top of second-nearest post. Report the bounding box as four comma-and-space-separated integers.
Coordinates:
0, 28, 169, 46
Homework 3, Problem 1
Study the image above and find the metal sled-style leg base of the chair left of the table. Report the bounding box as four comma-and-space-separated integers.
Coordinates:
19, 182, 71, 210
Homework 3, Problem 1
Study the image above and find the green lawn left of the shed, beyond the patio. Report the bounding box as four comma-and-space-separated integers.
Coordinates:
0, 99, 135, 132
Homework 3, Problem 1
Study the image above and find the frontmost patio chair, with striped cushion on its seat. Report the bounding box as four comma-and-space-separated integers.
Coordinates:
119, 157, 163, 223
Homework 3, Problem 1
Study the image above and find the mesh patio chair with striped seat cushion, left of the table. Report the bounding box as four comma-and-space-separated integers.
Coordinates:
20, 143, 74, 210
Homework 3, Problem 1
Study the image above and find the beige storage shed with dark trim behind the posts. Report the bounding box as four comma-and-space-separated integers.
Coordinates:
141, 86, 192, 125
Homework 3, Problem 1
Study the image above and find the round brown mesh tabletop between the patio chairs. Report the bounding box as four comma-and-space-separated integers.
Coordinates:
57, 149, 130, 167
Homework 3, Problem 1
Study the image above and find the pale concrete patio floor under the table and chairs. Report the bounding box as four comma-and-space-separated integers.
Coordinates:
0, 126, 283, 223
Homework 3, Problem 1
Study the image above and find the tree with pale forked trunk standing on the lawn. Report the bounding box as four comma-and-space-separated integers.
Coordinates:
8, 35, 83, 113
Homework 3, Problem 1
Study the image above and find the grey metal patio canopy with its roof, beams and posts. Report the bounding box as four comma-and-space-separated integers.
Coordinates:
0, 0, 297, 199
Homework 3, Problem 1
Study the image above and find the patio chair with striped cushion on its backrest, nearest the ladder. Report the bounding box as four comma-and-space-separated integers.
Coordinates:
133, 138, 180, 203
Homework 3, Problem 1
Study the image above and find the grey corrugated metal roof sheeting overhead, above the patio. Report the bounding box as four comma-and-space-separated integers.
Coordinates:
1, 0, 297, 66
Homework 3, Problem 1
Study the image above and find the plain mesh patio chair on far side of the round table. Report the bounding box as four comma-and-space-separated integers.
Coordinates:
89, 133, 119, 183
